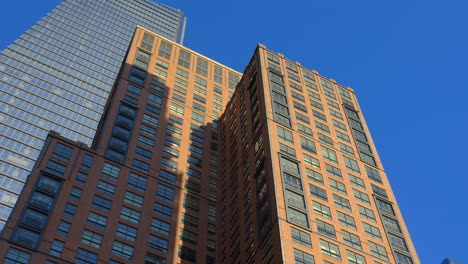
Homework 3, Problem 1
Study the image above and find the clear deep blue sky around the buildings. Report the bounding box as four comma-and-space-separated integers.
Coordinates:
0, 0, 468, 264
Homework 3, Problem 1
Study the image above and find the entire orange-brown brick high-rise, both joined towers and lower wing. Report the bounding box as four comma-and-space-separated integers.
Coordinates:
0, 27, 419, 263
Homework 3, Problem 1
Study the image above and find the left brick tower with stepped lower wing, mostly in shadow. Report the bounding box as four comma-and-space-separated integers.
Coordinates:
0, 28, 241, 263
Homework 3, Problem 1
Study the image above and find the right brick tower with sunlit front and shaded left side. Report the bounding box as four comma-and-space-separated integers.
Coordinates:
218, 45, 419, 263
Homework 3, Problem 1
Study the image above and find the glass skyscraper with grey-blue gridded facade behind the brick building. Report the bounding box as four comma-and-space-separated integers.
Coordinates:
0, 0, 186, 230
